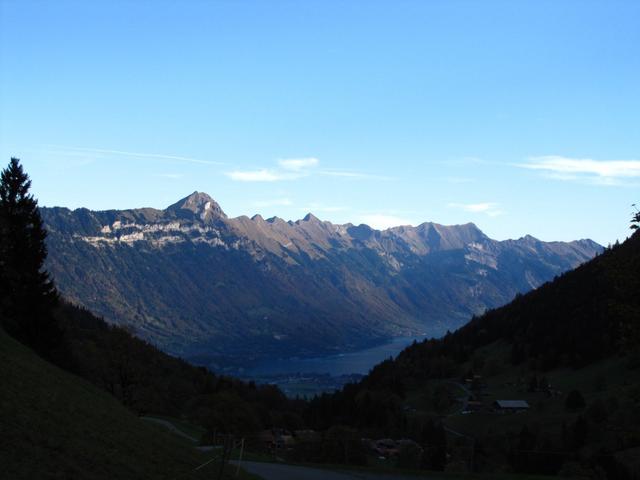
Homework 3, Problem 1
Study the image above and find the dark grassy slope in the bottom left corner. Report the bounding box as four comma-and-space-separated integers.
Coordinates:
0, 329, 255, 480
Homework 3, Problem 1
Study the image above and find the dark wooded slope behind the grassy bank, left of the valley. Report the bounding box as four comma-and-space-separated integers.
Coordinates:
56, 303, 299, 434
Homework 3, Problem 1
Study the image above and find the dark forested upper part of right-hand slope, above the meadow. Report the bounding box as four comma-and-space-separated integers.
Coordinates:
398, 233, 640, 374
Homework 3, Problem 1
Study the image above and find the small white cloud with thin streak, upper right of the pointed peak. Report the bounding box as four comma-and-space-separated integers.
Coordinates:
225, 157, 391, 182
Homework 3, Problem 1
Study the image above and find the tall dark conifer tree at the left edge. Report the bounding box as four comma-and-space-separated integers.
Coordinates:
0, 158, 61, 357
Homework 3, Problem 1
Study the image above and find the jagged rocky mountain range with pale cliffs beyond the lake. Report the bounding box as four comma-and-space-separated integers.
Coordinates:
42, 192, 601, 357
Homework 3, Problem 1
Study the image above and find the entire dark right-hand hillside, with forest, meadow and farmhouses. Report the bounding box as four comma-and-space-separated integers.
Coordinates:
307, 233, 640, 479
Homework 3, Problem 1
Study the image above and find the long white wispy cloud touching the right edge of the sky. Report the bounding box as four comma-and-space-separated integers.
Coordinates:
517, 155, 640, 185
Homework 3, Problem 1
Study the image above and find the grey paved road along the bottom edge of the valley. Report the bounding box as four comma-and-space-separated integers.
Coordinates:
235, 462, 443, 480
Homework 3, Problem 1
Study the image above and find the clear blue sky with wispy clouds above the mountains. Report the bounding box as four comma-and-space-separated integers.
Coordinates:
0, 0, 640, 244
